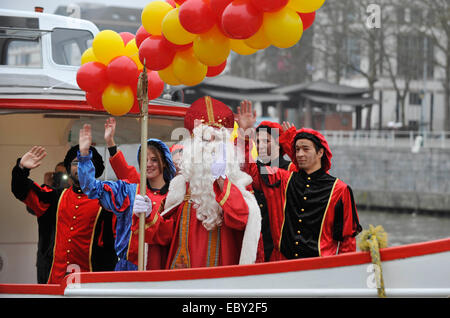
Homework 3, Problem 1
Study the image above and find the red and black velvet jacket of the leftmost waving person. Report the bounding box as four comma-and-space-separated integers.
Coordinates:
11, 160, 117, 284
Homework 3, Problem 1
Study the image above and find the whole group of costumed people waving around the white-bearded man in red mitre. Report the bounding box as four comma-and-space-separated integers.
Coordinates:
12, 96, 361, 283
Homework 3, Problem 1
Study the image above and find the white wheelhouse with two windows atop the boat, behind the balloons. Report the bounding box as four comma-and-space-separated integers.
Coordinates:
0, 9, 99, 87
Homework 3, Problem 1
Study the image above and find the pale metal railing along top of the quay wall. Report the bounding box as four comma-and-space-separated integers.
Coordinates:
321, 130, 450, 152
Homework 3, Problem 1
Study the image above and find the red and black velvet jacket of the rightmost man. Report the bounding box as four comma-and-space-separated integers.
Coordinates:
244, 134, 360, 261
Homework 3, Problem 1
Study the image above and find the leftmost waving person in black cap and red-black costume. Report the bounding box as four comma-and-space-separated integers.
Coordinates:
11, 145, 117, 284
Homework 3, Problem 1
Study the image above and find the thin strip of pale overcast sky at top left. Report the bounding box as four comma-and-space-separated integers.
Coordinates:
0, 0, 154, 13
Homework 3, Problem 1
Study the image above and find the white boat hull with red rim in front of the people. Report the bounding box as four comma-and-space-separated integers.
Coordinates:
0, 238, 450, 298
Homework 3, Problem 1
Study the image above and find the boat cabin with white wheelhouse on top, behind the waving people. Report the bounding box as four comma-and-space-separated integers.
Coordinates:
0, 9, 189, 283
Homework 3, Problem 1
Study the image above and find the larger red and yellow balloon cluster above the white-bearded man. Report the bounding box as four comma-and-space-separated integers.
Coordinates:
136, 0, 325, 86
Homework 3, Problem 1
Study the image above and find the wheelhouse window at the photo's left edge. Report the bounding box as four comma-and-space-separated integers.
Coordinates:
0, 38, 42, 67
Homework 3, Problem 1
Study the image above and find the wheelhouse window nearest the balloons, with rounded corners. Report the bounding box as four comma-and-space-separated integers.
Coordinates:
52, 28, 94, 66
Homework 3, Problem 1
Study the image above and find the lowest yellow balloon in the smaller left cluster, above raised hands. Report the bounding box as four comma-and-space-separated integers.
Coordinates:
102, 84, 134, 116
